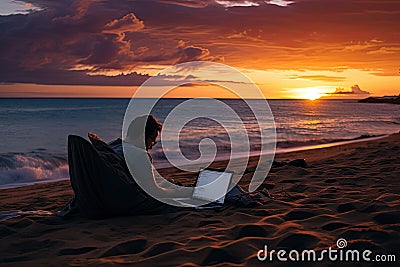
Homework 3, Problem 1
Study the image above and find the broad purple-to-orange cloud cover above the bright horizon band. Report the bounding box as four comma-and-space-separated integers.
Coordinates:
0, 0, 400, 87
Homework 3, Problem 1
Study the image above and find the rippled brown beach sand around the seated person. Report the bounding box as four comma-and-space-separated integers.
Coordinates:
0, 134, 400, 266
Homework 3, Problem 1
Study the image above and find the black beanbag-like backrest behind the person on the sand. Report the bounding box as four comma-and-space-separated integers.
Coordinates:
68, 135, 174, 218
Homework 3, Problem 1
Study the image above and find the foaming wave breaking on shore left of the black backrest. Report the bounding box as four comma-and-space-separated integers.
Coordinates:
0, 152, 69, 186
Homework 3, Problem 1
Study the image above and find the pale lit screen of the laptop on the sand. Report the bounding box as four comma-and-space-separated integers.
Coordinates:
192, 169, 233, 204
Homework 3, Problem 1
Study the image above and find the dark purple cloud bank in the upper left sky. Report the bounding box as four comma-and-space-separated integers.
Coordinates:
0, 0, 220, 85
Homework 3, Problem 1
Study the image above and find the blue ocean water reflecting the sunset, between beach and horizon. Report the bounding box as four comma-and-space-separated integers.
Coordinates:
0, 98, 400, 188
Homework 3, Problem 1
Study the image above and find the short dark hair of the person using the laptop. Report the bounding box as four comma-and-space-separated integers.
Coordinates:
126, 114, 162, 139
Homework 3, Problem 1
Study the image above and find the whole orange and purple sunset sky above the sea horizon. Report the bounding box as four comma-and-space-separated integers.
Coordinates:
0, 0, 400, 99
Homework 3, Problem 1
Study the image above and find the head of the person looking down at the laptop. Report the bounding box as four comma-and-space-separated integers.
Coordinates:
125, 114, 162, 150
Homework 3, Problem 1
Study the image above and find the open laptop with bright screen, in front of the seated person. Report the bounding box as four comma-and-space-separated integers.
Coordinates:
173, 168, 233, 209
